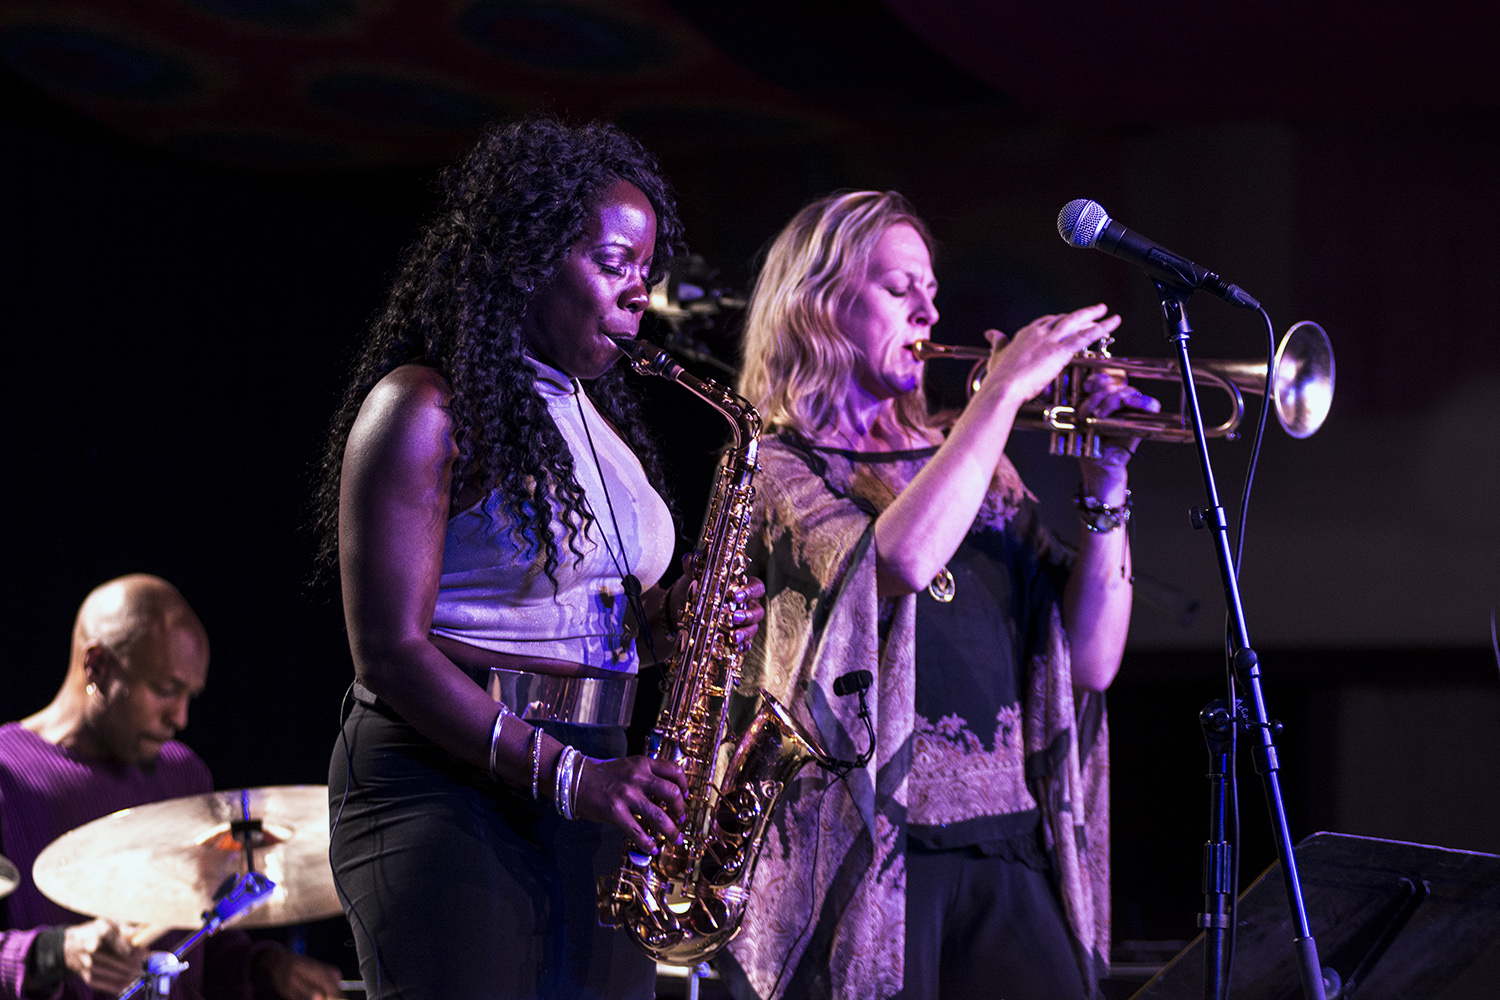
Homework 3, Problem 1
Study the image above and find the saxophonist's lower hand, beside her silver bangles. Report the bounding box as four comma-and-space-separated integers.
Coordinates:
573, 757, 687, 855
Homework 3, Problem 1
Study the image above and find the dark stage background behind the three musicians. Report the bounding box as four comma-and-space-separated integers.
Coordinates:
0, 0, 1500, 999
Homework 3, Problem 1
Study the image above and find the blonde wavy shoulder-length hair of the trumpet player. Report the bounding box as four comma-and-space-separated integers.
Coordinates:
740, 190, 933, 438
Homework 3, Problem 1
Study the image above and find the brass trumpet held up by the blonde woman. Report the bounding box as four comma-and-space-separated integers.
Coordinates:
911, 319, 1334, 457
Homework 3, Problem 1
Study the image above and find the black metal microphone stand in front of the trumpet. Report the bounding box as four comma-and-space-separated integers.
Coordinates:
1154, 280, 1326, 1000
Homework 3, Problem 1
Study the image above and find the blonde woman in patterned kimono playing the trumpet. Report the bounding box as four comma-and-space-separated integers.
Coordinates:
726, 192, 1160, 1000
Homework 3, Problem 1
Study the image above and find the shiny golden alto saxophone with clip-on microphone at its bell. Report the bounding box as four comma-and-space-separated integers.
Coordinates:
599, 340, 830, 966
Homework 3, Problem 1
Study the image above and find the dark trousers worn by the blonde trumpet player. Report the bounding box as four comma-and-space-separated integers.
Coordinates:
900, 849, 1089, 1000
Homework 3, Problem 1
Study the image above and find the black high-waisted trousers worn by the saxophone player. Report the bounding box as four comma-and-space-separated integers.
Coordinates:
329, 705, 656, 1000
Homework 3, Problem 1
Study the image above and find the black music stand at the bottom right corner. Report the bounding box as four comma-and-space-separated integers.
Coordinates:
1131, 834, 1500, 1000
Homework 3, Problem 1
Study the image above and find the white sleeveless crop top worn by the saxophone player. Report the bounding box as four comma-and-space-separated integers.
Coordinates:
432, 358, 675, 673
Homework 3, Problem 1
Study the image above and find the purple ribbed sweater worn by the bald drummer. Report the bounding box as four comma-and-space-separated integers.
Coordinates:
0, 723, 266, 1000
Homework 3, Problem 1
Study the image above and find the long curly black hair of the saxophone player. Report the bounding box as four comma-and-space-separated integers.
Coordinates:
314, 117, 683, 585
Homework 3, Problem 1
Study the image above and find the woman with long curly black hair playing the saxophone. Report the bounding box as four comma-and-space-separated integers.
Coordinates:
312, 120, 761, 1000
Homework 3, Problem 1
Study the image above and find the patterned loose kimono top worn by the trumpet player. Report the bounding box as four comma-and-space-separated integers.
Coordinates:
720, 435, 1110, 1000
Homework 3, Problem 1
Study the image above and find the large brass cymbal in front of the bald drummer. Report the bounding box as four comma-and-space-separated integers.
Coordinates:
32, 784, 342, 930
